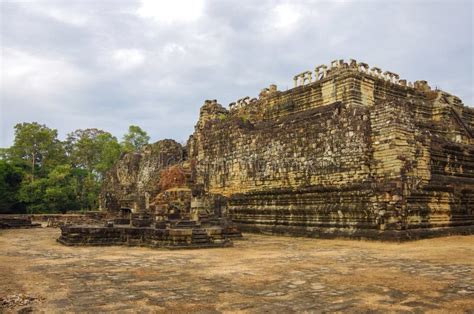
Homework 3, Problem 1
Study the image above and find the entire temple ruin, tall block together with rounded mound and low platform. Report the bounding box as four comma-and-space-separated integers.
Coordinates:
61, 60, 474, 246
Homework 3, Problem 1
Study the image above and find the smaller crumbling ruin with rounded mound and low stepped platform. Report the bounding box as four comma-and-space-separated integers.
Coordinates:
58, 140, 242, 249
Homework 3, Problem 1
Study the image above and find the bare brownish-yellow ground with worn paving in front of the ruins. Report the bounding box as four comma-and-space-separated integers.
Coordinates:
0, 228, 474, 313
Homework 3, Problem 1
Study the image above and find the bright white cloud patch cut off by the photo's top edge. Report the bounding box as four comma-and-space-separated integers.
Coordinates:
137, 0, 204, 23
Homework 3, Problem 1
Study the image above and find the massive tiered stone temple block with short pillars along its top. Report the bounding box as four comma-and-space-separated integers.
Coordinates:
189, 61, 474, 238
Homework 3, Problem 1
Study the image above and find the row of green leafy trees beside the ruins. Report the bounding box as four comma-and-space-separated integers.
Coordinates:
0, 122, 150, 213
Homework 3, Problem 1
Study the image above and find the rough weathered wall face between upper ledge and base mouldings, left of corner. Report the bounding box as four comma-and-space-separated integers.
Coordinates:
191, 102, 370, 196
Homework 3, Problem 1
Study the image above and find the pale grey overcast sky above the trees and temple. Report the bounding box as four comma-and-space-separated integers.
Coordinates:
0, 0, 474, 147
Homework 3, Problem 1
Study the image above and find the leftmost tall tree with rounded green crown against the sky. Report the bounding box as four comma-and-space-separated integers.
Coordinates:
8, 122, 64, 180
